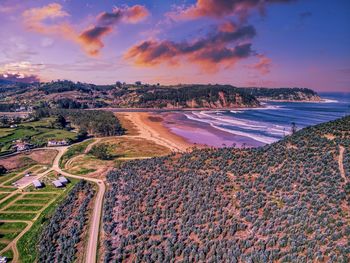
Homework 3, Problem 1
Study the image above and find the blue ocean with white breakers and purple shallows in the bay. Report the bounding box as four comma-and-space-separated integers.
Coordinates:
163, 93, 350, 147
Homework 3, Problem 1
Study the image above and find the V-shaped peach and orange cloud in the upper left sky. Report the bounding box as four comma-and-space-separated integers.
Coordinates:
23, 3, 149, 56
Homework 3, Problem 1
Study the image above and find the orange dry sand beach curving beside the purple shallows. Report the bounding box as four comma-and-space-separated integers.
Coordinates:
115, 112, 194, 152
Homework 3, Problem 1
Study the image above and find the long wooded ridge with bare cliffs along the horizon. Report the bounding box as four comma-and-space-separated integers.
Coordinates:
0, 80, 320, 110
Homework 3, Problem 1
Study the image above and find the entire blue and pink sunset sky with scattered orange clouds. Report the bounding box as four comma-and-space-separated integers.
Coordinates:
0, 0, 350, 91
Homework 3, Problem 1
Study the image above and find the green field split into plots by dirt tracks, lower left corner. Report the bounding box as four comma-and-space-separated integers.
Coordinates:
0, 171, 78, 262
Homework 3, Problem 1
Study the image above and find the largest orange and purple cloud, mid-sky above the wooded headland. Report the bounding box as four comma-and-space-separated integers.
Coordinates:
124, 22, 256, 72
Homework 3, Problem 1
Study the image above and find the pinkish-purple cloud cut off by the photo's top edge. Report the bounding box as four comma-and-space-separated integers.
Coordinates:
168, 0, 296, 20
